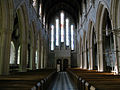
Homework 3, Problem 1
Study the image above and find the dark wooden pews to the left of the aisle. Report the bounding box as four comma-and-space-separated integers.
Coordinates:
0, 69, 56, 90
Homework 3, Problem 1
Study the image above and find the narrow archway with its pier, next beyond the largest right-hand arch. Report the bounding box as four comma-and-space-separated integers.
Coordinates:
88, 20, 98, 70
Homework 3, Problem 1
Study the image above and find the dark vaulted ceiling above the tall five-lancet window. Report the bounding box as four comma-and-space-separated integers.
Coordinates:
42, 0, 83, 23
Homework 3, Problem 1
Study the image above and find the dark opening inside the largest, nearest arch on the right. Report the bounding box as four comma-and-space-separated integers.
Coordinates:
102, 9, 115, 71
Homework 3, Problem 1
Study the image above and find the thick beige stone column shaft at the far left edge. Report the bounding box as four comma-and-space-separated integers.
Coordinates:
0, 29, 11, 75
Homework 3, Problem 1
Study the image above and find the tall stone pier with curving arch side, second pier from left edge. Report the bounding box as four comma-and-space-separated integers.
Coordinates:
17, 4, 29, 72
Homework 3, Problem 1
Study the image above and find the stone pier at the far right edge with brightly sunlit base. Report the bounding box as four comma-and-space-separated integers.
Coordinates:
110, 0, 120, 73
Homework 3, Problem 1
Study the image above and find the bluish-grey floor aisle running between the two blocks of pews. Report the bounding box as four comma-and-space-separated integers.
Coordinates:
48, 72, 78, 90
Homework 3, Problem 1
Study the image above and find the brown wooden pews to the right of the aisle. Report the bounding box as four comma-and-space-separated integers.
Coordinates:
67, 68, 120, 90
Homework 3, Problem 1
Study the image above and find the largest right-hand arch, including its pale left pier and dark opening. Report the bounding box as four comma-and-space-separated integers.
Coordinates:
96, 3, 114, 71
